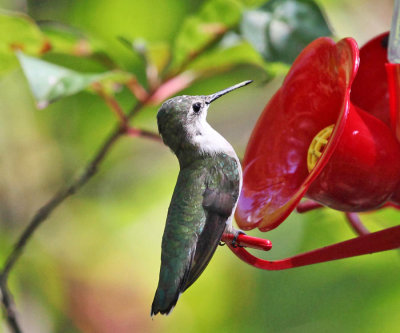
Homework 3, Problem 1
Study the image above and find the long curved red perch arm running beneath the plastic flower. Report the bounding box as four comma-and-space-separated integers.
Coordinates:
227, 226, 400, 270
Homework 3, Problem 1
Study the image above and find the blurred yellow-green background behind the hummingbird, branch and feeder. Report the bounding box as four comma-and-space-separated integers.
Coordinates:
0, 0, 400, 333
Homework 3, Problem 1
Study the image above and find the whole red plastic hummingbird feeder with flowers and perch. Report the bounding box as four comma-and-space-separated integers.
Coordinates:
223, 27, 400, 270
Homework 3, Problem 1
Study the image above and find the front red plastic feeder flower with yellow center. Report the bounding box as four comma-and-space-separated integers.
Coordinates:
236, 34, 400, 231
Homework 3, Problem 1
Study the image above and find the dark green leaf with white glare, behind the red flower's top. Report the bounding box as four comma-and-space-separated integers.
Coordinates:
241, 0, 332, 64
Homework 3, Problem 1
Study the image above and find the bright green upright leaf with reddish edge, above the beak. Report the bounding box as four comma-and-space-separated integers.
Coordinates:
171, 0, 243, 70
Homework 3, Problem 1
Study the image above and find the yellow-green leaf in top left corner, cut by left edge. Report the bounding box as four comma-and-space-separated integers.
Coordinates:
0, 10, 49, 73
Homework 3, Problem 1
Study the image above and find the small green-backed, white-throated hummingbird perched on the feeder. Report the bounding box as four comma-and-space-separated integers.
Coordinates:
151, 80, 252, 316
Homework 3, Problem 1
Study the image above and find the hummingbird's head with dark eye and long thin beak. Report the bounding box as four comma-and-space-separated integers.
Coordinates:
157, 81, 252, 154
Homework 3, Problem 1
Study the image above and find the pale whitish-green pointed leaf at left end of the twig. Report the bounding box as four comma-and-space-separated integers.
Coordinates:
17, 52, 130, 108
